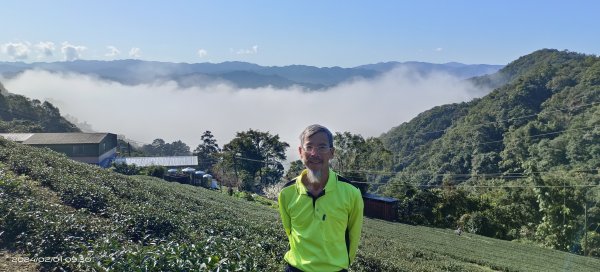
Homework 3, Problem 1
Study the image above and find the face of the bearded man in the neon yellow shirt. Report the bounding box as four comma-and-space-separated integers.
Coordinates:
298, 132, 334, 171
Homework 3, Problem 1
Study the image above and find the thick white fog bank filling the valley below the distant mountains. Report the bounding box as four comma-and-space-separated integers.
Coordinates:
4, 69, 483, 163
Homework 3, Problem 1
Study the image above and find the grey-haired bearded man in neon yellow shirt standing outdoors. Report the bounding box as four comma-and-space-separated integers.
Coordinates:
278, 125, 363, 271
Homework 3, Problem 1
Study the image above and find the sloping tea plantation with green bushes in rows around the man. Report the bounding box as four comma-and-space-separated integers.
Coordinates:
0, 138, 600, 271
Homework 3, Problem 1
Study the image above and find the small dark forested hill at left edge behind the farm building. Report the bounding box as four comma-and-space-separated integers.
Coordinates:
0, 83, 80, 133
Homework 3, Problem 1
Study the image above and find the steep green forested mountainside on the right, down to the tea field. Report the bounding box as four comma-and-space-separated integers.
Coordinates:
381, 49, 600, 256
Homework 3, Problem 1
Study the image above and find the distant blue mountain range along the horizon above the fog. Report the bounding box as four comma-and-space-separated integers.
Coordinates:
0, 60, 504, 90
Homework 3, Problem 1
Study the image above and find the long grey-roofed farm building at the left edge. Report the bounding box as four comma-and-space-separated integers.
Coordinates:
0, 133, 117, 167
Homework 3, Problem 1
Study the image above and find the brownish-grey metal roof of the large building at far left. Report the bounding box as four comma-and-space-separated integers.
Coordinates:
23, 132, 108, 144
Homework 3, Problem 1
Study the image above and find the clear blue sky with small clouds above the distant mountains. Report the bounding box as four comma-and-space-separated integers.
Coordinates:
0, 0, 600, 67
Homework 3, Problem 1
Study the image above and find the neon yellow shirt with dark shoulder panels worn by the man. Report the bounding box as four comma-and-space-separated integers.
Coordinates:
278, 169, 364, 271
